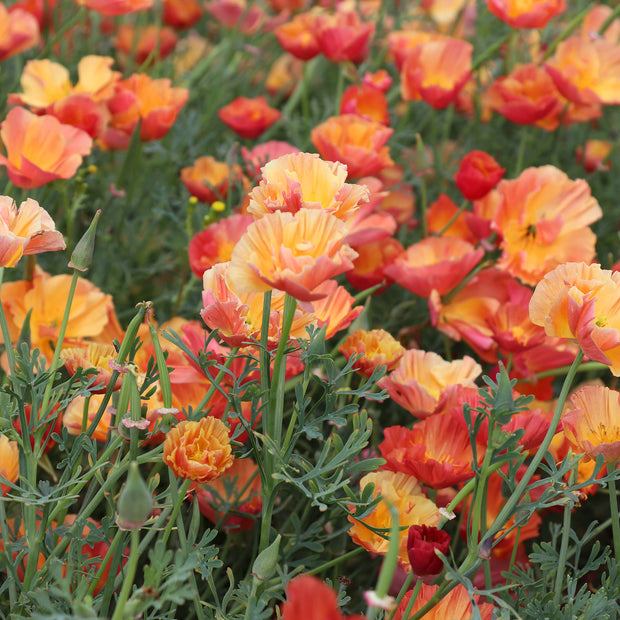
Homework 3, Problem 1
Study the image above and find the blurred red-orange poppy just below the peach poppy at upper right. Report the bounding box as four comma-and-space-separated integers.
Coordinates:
484, 63, 565, 131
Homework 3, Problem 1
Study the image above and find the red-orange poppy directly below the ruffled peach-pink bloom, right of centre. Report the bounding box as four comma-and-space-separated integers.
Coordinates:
379, 410, 484, 489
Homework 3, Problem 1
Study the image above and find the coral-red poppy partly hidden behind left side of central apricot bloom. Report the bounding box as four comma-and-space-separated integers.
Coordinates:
188, 214, 254, 278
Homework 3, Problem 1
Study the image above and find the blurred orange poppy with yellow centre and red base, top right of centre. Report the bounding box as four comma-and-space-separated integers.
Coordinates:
400, 38, 474, 110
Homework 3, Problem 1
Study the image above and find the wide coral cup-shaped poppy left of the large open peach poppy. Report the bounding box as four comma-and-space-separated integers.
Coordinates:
384, 237, 484, 297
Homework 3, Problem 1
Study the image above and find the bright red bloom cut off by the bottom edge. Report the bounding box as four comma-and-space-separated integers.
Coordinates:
280, 575, 365, 620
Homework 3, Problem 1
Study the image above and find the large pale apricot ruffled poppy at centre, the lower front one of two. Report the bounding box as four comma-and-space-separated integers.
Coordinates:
229, 209, 357, 302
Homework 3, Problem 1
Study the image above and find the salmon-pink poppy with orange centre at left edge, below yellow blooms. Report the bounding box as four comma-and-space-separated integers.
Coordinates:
0, 108, 92, 189
